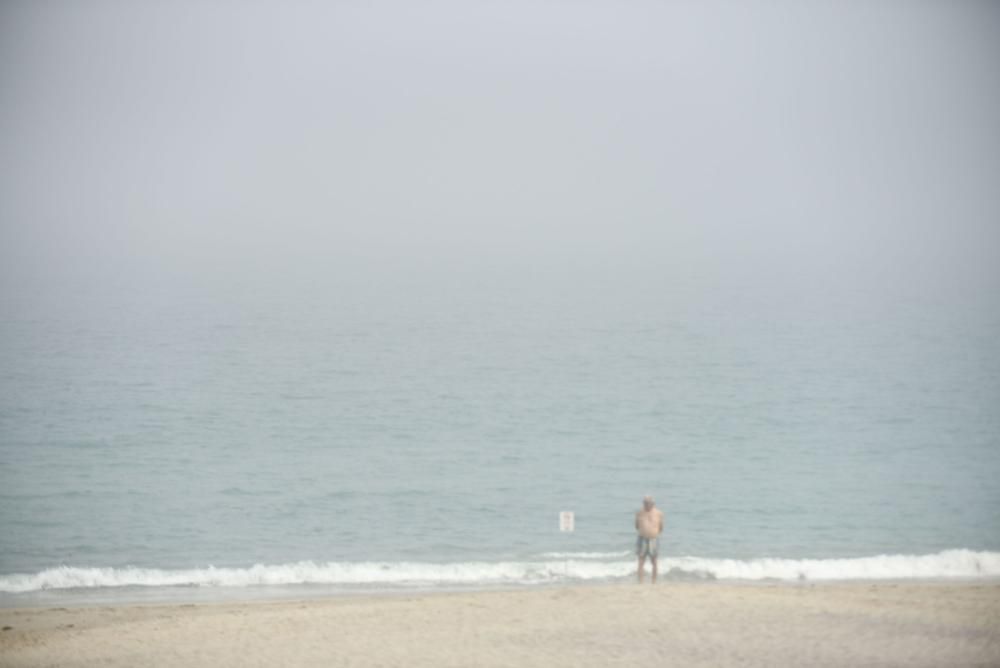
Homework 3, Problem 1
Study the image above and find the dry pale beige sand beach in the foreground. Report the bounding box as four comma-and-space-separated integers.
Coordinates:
0, 583, 1000, 668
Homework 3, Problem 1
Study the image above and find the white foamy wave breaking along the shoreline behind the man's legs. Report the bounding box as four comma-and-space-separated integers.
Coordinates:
0, 550, 1000, 593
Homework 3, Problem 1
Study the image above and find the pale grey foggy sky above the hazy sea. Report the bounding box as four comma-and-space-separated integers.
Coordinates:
0, 0, 1000, 292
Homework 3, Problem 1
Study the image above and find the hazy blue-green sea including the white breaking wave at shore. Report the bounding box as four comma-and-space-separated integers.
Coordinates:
0, 274, 1000, 594
